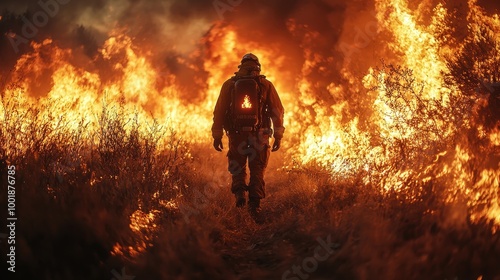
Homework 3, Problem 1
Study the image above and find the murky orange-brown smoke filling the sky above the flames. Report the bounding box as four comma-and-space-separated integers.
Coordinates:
0, 0, 500, 103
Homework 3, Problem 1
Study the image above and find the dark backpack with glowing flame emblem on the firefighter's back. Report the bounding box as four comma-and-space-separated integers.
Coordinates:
226, 75, 266, 132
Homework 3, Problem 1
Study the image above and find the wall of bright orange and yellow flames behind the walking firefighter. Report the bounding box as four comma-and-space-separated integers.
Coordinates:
0, 0, 500, 234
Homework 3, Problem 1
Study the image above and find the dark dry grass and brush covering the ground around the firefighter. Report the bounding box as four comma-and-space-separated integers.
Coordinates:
0, 61, 500, 279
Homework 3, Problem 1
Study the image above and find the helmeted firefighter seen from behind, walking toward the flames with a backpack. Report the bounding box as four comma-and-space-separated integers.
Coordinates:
212, 53, 285, 221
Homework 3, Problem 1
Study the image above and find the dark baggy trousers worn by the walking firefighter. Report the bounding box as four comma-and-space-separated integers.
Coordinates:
227, 131, 270, 200
